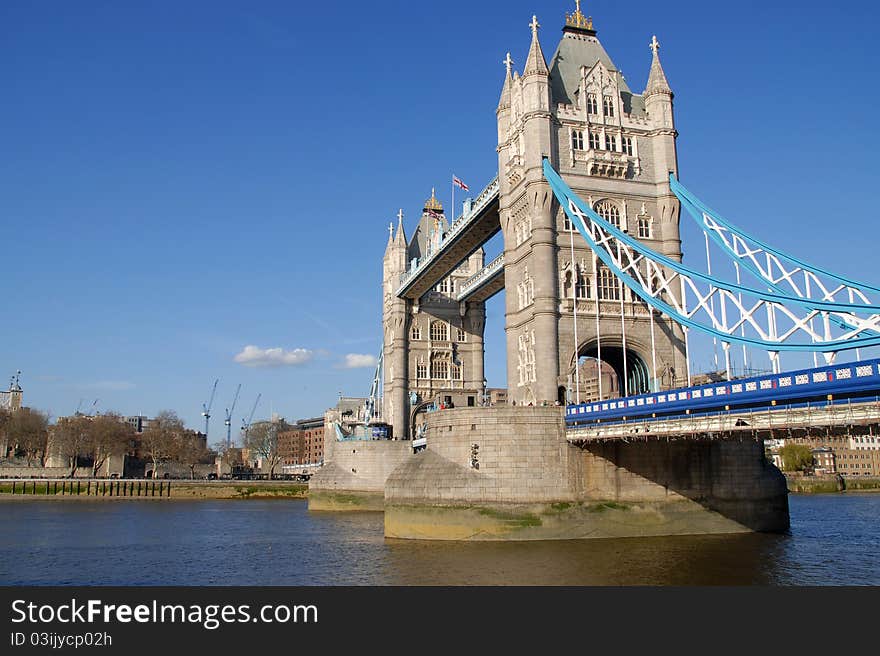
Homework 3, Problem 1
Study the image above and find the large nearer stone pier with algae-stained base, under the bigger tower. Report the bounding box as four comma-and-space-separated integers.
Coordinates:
385, 407, 789, 540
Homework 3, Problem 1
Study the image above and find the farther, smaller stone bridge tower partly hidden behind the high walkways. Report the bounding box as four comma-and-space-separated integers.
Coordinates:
382, 191, 486, 439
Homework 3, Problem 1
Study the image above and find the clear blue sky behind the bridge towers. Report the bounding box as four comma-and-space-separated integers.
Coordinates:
0, 0, 880, 442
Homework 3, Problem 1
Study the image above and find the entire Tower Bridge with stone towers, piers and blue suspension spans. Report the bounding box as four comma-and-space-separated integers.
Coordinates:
310, 0, 880, 539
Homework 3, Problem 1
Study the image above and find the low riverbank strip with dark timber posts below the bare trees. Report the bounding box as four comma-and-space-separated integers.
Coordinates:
0, 479, 309, 500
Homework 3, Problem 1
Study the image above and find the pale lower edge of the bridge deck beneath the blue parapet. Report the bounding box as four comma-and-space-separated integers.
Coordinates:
566, 400, 880, 445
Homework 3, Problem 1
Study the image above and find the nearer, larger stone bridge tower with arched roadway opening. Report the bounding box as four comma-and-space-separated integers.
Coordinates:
497, 1, 686, 405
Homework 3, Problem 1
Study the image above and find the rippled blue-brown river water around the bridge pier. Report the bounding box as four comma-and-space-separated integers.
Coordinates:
0, 493, 880, 586
